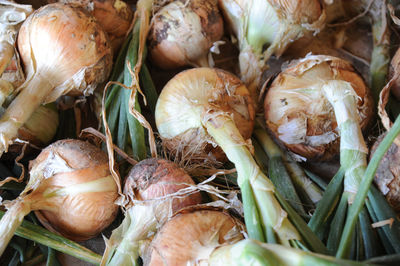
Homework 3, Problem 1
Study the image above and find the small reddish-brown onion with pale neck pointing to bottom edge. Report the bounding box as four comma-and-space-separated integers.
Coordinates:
102, 158, 201, 265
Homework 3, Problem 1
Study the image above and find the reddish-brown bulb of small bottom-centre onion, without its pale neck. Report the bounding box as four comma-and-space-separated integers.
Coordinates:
124, 158, 201, 213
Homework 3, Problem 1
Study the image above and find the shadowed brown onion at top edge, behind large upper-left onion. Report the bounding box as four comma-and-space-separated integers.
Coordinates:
58, 0, 133, 53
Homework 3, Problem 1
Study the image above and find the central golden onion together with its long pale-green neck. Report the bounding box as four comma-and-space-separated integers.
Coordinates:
155, 68, 324, 252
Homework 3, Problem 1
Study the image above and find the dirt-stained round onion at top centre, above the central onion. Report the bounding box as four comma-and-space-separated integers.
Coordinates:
148, 0, 224, 69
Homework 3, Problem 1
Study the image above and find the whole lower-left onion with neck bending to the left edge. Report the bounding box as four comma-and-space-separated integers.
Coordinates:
0, 140, 118, 254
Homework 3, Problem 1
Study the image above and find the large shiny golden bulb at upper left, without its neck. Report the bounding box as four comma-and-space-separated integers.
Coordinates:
17, 3, 112, 98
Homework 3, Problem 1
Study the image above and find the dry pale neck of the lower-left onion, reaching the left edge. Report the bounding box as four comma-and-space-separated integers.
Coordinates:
0, 198, 31, 256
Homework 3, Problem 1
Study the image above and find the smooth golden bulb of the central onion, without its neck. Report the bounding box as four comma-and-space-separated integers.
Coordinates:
155, 68, 255, 164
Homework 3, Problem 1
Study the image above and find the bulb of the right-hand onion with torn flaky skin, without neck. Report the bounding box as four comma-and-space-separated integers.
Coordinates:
264, 55, 373, 160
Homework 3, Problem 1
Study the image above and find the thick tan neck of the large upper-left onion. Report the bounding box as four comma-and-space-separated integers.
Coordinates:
0, 74, 54, 156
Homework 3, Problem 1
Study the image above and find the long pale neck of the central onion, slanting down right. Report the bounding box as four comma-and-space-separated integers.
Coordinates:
204, 115, 300, 245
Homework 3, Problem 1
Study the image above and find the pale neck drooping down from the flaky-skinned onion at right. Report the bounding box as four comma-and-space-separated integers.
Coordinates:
322, 80, 368, 203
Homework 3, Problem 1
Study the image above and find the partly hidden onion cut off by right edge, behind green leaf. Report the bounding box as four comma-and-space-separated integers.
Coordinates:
370, 134, 400, 213
